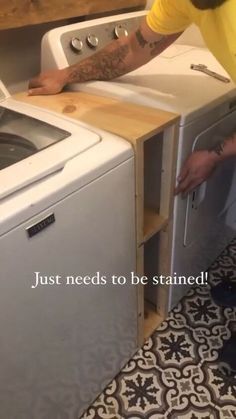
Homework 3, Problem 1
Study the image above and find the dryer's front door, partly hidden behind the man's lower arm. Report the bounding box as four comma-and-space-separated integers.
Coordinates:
184, 111, 236, 246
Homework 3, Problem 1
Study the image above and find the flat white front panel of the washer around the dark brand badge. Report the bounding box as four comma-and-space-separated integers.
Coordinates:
0, 159, 137, 419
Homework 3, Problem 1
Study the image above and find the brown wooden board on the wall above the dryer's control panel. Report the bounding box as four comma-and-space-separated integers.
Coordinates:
0, 0, 146, 29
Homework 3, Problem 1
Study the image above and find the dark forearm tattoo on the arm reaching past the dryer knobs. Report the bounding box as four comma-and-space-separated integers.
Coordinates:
69, 45, 129, 83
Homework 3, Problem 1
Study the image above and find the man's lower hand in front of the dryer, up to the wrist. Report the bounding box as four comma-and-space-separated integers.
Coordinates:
175, 150, 218, 195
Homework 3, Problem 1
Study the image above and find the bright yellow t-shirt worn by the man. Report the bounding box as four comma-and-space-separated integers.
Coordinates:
147, 0, 236, 83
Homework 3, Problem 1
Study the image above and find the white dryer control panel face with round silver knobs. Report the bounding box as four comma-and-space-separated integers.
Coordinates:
60, 14, 145, 65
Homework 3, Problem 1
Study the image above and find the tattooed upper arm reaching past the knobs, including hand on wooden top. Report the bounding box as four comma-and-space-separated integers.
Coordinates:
29, 20, 181, 95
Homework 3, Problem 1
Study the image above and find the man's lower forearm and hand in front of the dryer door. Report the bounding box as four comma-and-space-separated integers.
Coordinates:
175, 133, 236, 195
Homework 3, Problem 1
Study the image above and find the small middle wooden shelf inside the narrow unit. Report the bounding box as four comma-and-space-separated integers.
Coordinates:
143, 208, 168, 243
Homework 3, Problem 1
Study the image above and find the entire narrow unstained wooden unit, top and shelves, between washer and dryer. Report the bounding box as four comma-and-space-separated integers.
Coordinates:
14, 92, 179, 346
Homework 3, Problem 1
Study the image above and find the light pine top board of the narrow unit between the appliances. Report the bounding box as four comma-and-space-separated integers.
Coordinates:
13, 92, 179, 147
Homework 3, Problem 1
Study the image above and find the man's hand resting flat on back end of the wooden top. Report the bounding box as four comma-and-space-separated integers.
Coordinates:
28, 69, 67, 96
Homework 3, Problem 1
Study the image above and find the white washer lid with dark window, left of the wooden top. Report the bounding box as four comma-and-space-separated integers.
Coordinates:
0, 100, 101, 199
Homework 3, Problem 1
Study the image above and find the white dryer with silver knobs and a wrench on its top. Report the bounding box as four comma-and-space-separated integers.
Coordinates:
42, 12, 236, 308
